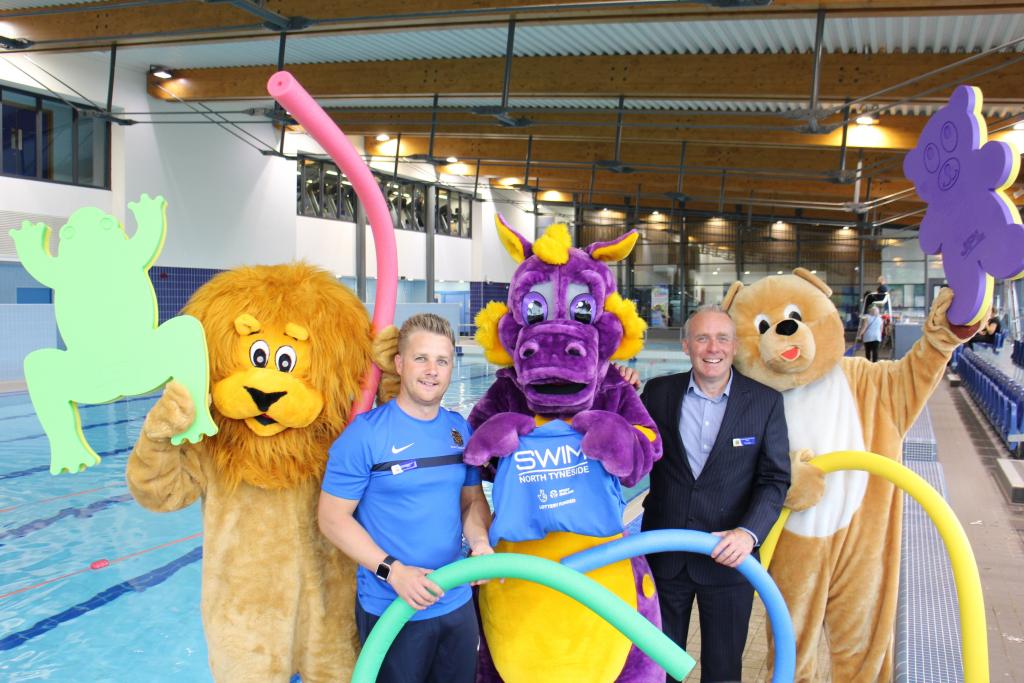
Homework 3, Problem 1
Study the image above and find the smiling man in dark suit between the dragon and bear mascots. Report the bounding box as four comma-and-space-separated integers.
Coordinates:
641, 306, 790, 681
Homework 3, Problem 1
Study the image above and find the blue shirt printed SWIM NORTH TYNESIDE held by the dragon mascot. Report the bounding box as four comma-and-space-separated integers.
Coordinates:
490, 420, 626, 546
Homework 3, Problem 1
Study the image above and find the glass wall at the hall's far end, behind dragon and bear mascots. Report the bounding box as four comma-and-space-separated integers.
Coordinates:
578, 207, 884, 330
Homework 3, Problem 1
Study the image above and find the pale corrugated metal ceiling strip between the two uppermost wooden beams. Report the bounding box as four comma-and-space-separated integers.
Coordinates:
112, 11, 1024, 68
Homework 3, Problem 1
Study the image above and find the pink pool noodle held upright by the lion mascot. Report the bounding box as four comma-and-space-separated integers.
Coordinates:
266, 71, 398, 418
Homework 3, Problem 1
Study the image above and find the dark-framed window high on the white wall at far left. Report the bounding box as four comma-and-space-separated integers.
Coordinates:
0, 83, 110, 187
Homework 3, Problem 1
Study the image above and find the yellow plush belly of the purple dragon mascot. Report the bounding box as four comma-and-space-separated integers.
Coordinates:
480, 531, 637, 683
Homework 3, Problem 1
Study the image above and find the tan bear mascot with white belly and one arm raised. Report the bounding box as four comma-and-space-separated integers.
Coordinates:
723, 268, 973, 683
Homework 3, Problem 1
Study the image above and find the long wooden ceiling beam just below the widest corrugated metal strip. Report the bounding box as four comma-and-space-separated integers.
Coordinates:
148, 54, 1024, 104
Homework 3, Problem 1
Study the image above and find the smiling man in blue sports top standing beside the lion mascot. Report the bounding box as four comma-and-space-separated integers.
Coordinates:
318, 313, 494, 683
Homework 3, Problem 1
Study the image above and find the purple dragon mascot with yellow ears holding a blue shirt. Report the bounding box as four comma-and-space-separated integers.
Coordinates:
465, 217, 665, 683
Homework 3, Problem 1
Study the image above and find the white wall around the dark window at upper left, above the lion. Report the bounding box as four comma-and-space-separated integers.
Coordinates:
0, 52, 296, 268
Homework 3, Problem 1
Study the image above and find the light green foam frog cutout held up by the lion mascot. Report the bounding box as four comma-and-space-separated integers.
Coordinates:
10, 195, 217, 474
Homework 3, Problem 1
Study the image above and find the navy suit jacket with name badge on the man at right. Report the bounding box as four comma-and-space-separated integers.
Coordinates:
640, 369, 790, 585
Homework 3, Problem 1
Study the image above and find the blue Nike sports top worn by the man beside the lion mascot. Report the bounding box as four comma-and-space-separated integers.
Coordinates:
323, 400, 480, 621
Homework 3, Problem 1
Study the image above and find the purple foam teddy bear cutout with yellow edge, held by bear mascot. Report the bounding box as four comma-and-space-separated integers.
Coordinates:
903, 85, 1024, 325
